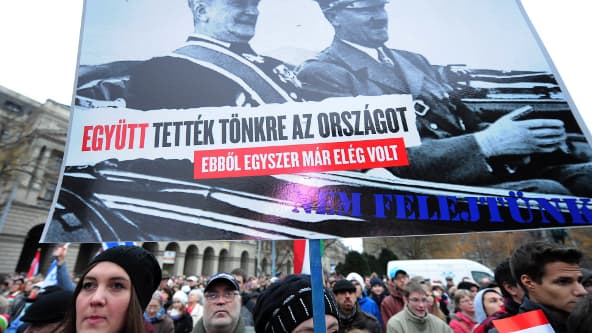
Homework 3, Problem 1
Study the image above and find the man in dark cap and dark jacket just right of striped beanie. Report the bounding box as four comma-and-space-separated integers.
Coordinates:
333, 279, 381, 333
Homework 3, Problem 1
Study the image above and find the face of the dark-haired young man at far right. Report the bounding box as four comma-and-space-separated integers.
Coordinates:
522, 261, 587, 313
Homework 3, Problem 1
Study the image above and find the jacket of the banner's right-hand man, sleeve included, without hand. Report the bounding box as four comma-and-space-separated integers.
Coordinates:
298, 40, 500, 184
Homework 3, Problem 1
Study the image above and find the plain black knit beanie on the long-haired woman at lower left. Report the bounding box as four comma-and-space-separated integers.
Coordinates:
87, 245, 162, 309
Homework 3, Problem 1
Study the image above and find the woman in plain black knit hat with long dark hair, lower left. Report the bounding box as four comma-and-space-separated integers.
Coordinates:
57, 246, 162, 333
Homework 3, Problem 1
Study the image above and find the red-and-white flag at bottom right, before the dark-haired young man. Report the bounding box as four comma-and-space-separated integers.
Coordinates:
493, 310, 555, 333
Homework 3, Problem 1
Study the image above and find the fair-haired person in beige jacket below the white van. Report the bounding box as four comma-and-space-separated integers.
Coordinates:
387, 281, 452, 333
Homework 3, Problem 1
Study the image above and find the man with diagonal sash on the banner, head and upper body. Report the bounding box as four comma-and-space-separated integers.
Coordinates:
125, 0, 300, 110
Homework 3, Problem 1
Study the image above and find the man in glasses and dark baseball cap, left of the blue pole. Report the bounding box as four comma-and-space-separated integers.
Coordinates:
192, 273, 252, 333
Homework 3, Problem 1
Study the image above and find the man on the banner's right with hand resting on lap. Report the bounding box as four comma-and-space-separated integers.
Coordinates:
298, 0, 592, 196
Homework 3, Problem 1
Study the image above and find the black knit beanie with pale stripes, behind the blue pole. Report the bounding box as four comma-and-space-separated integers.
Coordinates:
253, 275, 339, 333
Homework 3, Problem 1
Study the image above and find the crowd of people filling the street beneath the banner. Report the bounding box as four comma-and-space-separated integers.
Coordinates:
0, 242, 592, 333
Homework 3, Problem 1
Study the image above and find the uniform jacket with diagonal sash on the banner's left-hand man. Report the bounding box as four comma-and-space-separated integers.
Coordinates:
125, 35, 301, 110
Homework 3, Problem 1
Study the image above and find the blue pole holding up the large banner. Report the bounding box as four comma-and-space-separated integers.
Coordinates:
308, 239, 327, 332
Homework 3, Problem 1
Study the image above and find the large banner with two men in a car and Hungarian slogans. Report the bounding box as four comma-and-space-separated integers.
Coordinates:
44, 0, 592, 241
